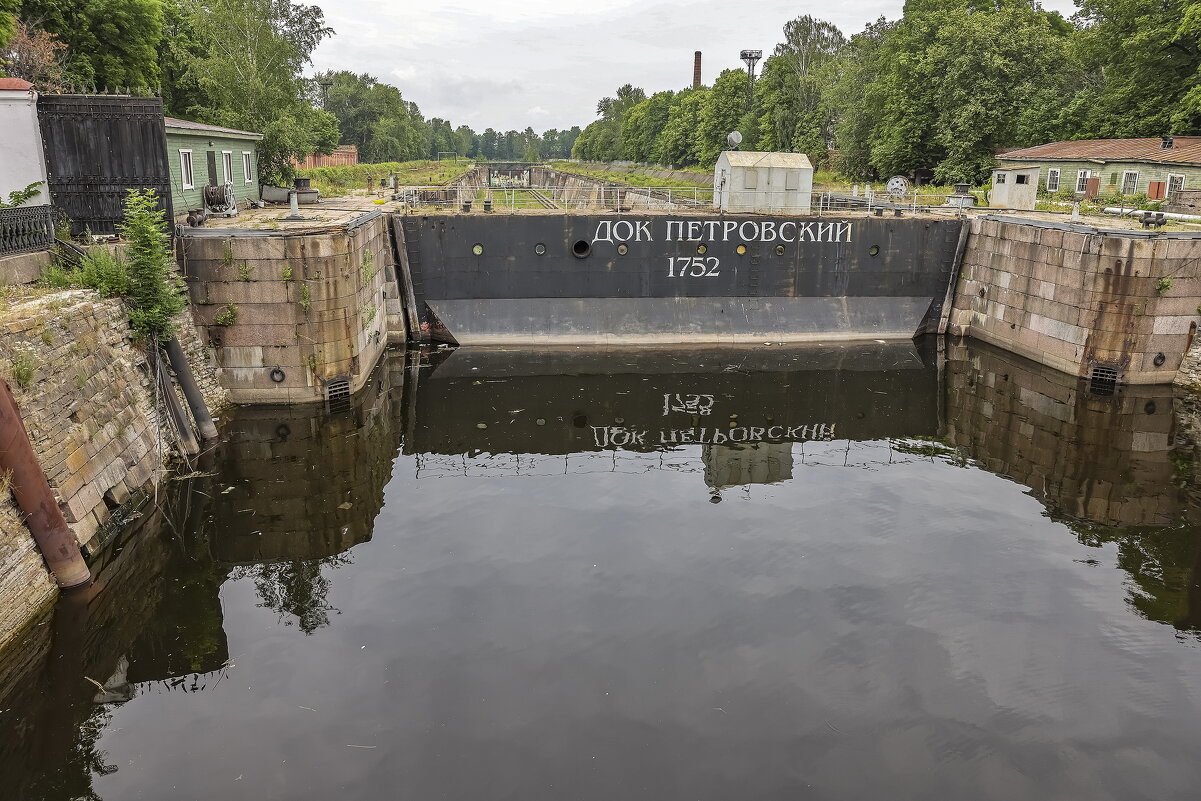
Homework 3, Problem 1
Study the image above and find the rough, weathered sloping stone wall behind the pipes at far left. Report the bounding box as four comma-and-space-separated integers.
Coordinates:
0, 289, 227, 645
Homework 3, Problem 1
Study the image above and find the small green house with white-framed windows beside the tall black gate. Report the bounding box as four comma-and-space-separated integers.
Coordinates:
165, 116, 263, 216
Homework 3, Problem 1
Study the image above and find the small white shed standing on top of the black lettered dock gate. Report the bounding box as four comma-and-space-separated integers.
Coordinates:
713, 150, 813, 214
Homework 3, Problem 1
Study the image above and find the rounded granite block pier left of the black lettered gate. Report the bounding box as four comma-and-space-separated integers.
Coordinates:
180, 214, 396, 404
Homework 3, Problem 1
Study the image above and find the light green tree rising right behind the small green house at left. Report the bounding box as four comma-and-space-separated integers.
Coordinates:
187, 0, 339, 183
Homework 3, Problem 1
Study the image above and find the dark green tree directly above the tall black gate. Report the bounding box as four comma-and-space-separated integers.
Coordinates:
18, 0, 163, 90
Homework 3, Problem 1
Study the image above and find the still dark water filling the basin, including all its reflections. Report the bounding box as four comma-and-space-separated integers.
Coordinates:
0, 342, 1201, 801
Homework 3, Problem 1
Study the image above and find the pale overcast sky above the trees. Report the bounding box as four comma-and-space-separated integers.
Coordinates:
310, 0, 1075, 133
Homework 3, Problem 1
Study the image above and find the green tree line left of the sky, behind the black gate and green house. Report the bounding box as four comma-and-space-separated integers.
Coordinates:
0, 0, 580, 183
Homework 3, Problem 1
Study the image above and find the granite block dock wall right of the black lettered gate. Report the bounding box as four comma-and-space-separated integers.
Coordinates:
949, 217, 1201, 384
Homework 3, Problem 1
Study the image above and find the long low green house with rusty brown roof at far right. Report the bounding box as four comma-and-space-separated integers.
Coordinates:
997, 136, 1201, 199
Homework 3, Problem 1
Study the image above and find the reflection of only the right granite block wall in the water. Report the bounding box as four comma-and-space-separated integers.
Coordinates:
946, 345, 1181, 526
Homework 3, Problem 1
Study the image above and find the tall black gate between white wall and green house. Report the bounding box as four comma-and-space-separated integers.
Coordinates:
37, 95, 173, 235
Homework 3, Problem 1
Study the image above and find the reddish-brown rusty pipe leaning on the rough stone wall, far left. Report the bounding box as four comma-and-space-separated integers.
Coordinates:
0, 379, 91, 588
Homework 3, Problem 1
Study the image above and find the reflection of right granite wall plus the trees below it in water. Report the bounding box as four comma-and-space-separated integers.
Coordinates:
946, 345, 1201, 630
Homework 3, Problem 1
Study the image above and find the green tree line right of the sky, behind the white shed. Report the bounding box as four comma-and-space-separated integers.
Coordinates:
573, 0, 1201, 184
